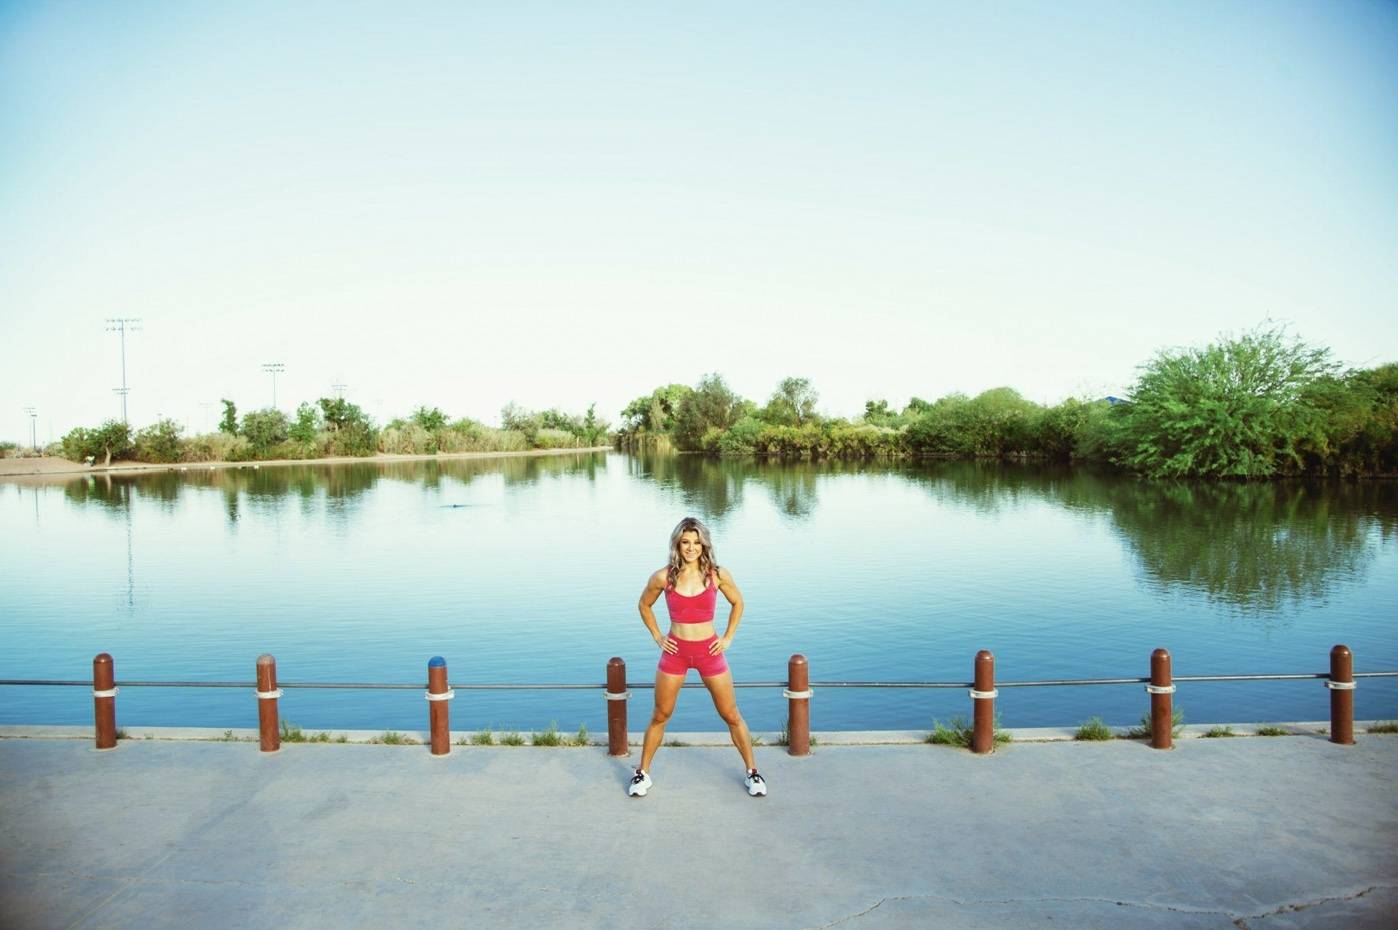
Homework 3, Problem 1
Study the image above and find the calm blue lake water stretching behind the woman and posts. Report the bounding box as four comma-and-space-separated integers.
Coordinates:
0, 453, 1398, 733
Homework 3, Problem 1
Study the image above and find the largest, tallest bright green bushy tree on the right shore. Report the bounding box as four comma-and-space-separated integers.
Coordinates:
1113, 329, 1336, 478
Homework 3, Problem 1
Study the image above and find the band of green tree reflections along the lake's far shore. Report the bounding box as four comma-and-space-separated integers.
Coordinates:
49, 453, 1398, 611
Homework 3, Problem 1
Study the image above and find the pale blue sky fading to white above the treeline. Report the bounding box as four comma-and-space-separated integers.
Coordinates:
0, 0, 1398, 442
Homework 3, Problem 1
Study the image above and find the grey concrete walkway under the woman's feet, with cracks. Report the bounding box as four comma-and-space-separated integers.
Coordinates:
0, 734, 1398, 930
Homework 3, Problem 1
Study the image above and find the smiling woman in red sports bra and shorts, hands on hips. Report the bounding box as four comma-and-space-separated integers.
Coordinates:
626, 516, 768, 797
